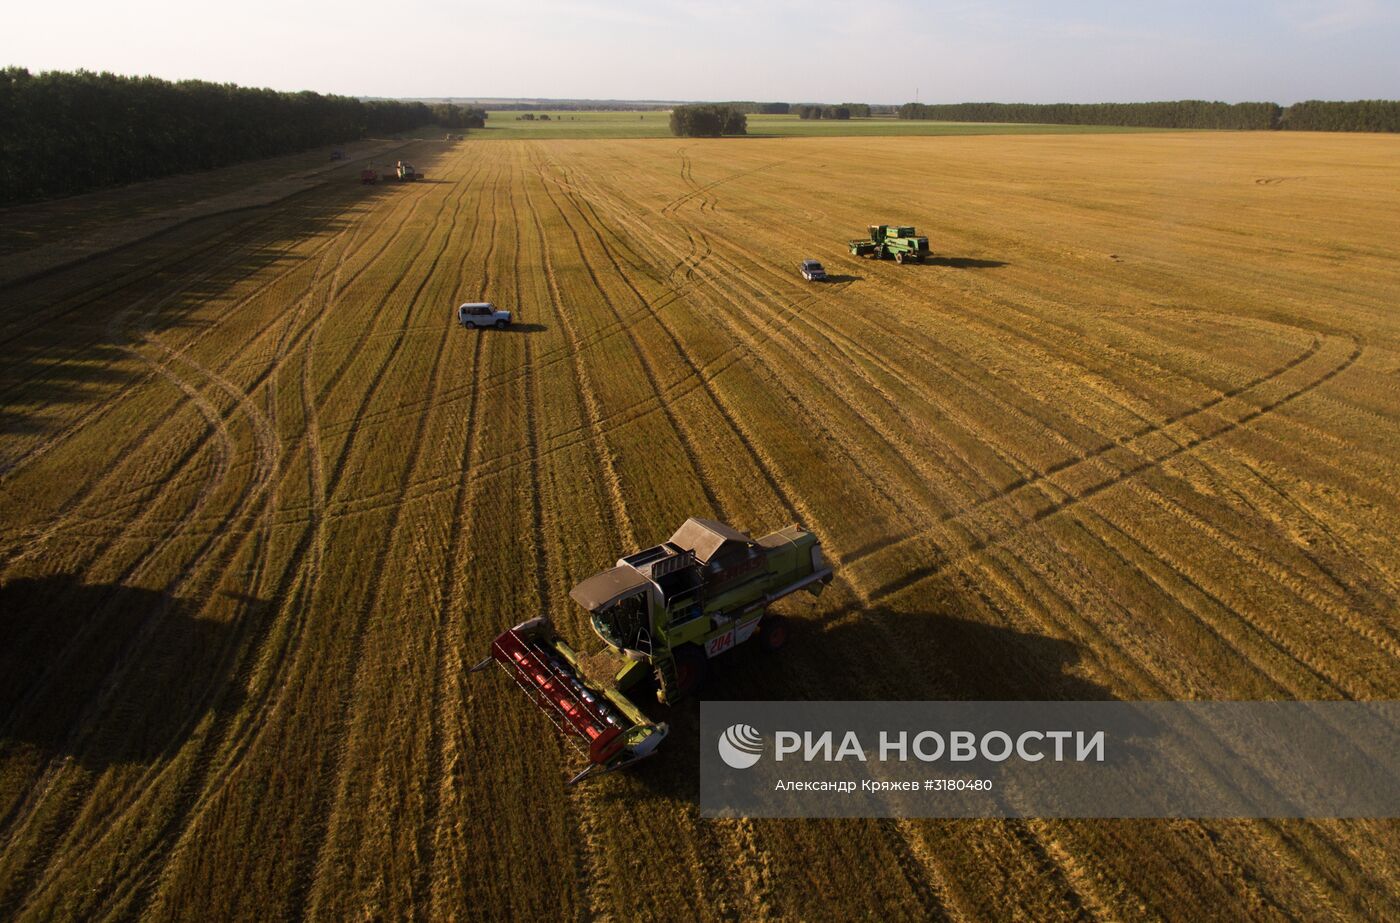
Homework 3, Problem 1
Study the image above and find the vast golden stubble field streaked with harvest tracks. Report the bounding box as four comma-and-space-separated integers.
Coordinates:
0, 133, 1400, 920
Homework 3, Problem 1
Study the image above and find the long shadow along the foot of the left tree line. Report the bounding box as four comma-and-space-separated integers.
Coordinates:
0, 144, 453, 456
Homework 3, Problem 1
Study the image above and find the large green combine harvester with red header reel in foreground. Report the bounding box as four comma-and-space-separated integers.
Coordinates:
472, 518, 832, 786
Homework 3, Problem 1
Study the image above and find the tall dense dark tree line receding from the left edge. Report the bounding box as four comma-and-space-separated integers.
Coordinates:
0, 67, 470, 203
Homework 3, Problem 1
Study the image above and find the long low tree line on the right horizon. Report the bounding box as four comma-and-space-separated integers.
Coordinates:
896, 99, 1400, 132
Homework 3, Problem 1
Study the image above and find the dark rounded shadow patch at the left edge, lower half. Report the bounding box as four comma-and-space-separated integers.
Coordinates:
0, 574, 270, 770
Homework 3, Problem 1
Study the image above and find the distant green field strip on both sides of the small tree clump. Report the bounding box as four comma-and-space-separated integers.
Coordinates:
450, 109, 1159, 140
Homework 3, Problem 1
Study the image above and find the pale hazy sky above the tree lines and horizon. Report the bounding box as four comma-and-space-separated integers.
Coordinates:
0, 0, 1400, 105
